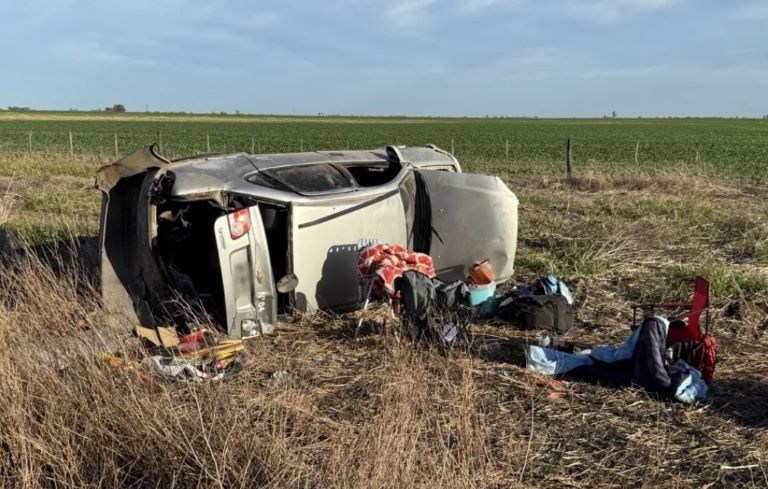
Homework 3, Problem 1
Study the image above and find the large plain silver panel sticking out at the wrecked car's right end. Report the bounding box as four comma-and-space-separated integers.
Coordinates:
418, 170, 518, 282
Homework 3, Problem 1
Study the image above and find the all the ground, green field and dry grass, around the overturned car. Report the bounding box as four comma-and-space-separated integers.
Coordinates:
0, 112, 768, 488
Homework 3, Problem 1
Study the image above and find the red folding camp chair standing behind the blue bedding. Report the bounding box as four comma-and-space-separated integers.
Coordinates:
632, 276, 717, 383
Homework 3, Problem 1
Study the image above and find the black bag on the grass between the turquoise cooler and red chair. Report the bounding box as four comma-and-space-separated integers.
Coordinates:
499, 295, 574, 334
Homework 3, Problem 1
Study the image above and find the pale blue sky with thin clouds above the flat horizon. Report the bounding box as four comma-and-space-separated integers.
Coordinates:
0, 0, 768, 117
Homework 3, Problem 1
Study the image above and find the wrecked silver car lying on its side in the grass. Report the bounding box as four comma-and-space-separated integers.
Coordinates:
97, 146, 517, 337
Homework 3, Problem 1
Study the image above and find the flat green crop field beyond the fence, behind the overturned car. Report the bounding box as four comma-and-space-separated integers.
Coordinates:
0, 112, 768, 183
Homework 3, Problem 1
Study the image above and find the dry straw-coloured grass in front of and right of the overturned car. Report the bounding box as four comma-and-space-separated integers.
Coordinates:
0, 169, 768, 488
